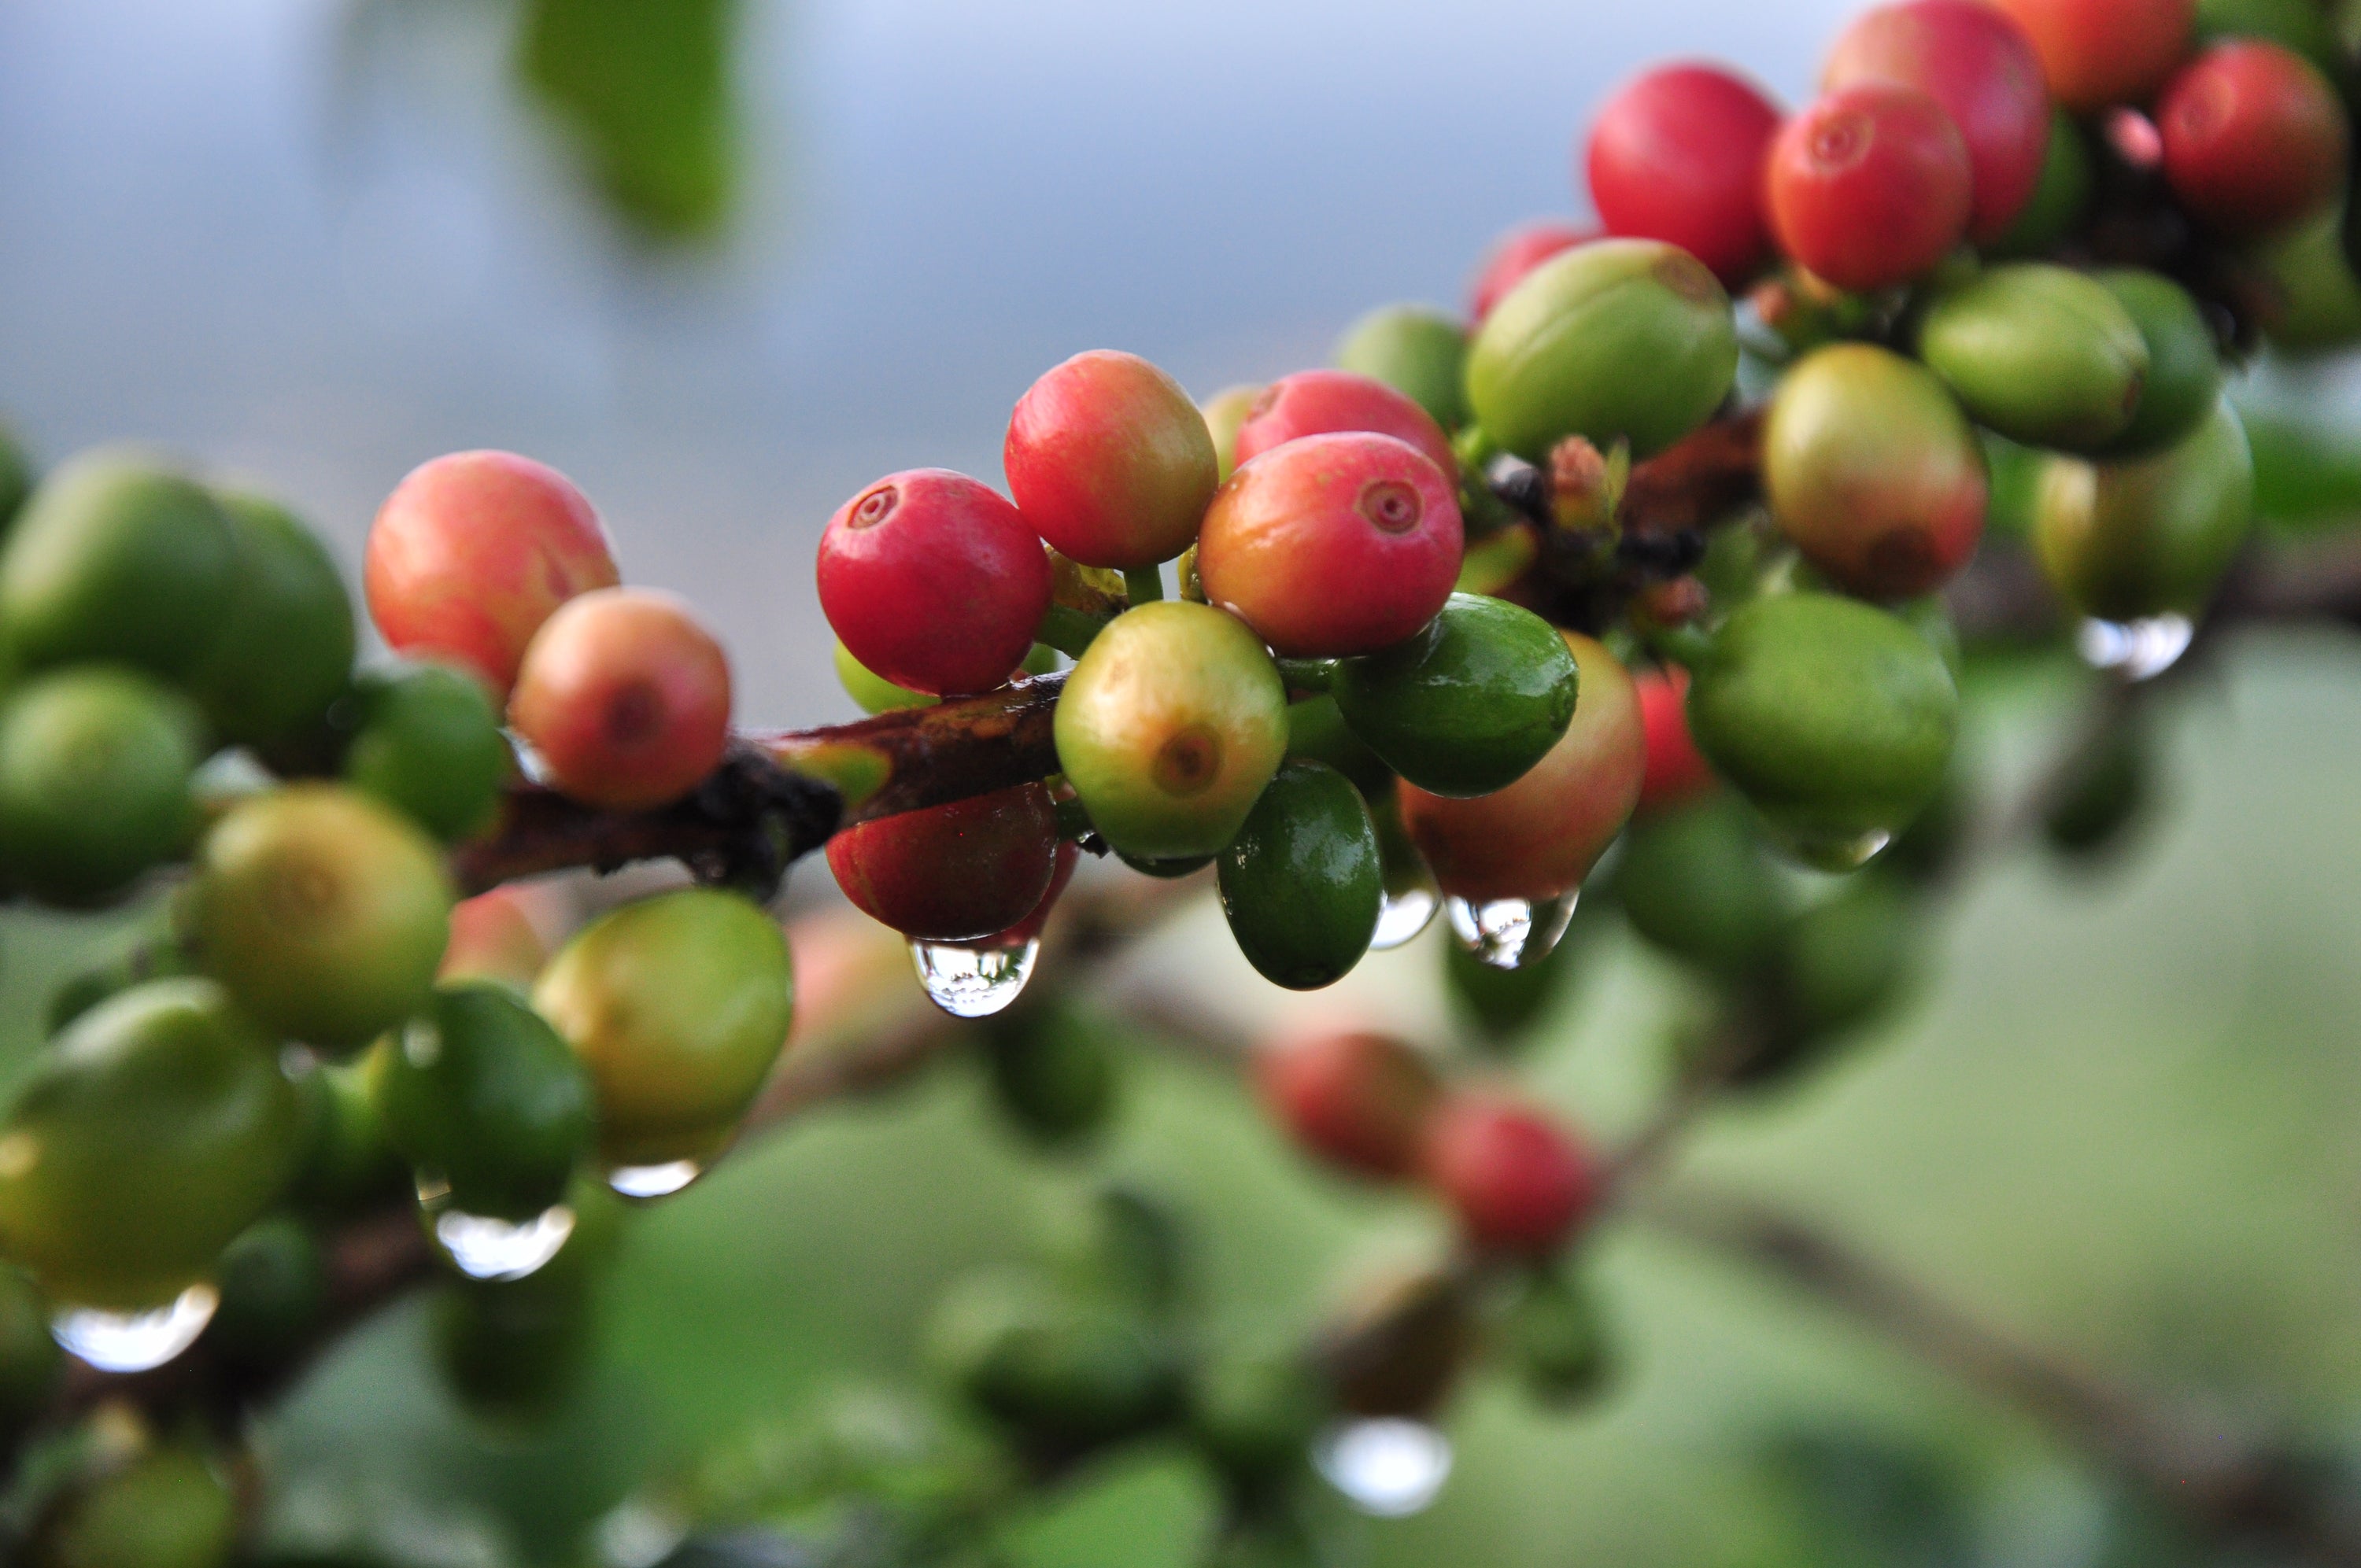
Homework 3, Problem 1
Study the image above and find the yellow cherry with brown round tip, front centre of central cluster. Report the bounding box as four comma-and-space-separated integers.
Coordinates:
1058, 602, 1287, 860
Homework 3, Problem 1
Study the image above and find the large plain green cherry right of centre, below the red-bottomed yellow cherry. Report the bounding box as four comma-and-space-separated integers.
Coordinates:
1688, 592, 1960, 869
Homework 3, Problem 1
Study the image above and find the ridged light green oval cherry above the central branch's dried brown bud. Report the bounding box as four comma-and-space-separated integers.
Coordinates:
1466, 238, 1738, 463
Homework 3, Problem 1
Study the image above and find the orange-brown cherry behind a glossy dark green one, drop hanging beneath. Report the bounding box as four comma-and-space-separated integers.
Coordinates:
1398, 633, 1648, 902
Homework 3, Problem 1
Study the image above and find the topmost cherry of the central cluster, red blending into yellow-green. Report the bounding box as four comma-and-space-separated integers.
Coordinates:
1001, 349, 1221, 569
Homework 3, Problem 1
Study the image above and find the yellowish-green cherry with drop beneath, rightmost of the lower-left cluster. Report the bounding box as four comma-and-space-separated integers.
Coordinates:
534, 888, 796, 1167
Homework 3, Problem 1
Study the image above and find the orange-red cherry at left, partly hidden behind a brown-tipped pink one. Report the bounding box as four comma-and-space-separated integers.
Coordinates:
361, 451, 621, 699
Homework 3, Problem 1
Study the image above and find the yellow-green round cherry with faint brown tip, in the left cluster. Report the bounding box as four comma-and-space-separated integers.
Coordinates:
182, 784, 453, 1049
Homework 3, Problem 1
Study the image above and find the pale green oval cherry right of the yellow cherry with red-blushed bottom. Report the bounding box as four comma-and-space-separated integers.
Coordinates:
1917, 262, 2149, 451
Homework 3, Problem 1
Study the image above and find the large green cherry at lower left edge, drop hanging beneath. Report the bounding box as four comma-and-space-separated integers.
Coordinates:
0, 980, 302, 1311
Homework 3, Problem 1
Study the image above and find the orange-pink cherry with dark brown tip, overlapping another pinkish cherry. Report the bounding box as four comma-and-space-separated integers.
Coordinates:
508, 588, 730, 810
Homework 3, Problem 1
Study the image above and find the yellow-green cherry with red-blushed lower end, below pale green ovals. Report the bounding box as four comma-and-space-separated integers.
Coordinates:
1761, 342, 1986, 600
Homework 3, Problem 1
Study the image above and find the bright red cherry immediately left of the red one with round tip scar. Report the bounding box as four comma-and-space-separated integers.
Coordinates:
1584, 64, 1778, 288
